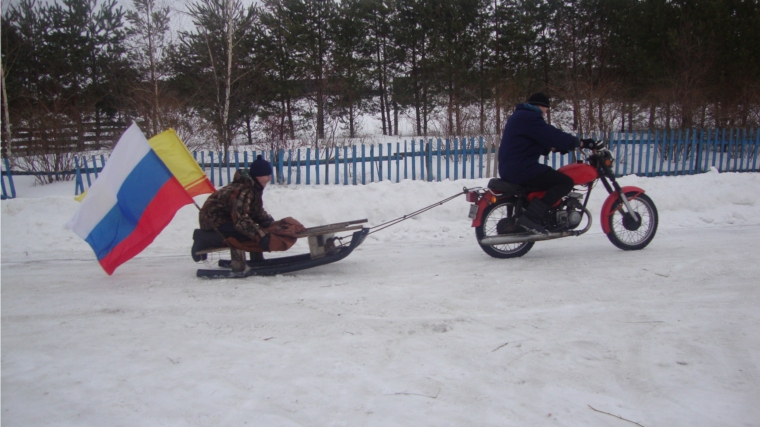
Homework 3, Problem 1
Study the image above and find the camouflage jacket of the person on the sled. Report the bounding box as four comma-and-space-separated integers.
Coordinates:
198, 169, 273, 239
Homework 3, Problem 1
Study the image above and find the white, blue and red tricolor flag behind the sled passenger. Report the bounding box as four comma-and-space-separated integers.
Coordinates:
67, 124, 214, 275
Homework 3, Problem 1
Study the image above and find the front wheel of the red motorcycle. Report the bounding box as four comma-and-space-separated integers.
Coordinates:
607, 193, 658, 251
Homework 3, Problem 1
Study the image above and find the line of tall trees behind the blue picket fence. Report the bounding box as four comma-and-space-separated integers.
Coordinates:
2, 0, 760, 160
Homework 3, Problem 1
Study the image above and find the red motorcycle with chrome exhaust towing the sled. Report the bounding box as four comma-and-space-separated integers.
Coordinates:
464, 143, 658, 258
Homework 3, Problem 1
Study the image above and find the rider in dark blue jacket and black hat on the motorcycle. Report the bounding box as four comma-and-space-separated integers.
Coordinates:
499, 92, 597, 234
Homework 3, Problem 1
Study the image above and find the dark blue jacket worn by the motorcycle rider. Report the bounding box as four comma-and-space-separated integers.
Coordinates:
499, 104, 580, 184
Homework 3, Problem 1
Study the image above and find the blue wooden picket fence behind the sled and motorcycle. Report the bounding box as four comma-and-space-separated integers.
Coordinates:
60, 129, 760, 194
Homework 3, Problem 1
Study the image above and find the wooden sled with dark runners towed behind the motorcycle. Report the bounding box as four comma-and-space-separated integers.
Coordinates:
196, 219, 369, 279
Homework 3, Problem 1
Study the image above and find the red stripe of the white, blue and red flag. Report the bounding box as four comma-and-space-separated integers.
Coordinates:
100, 177, 193, 275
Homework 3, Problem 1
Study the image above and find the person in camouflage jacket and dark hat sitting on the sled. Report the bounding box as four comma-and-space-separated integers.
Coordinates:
192, 156, 305, 270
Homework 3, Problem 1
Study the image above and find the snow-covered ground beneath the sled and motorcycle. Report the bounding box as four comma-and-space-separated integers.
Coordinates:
2, 172, 760, 427
